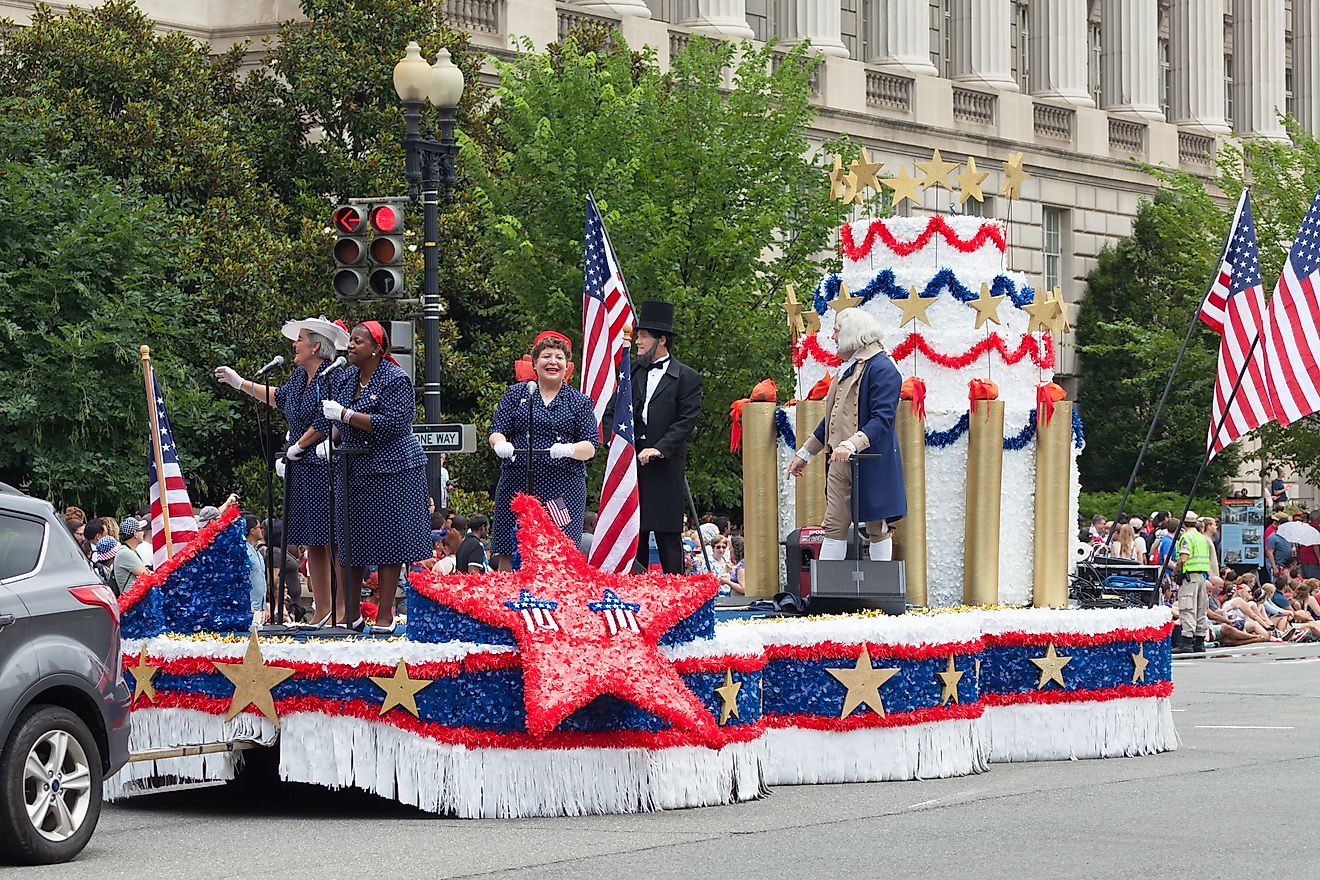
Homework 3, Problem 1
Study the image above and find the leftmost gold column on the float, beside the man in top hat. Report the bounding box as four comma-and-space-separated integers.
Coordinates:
742, 402, 779, 596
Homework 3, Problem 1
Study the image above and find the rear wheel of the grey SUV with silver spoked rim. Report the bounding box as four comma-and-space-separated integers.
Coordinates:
0, 706, 102, 864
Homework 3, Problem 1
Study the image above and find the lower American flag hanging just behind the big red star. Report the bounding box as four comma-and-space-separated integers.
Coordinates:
589, 347, 642, 574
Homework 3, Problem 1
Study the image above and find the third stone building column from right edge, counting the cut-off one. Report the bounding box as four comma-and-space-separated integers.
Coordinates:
1168, 0, 1230, 136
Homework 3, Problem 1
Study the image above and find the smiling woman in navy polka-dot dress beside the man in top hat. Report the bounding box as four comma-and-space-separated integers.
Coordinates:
487, 331, 599, 571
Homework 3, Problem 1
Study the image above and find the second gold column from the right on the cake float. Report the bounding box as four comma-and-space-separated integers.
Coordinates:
962, 400, 1003, 606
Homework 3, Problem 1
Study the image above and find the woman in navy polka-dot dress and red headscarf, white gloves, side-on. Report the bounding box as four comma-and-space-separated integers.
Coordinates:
322, 321, 432, 632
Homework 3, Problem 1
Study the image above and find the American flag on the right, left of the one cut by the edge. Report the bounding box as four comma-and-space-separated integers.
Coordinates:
1200, 190, 1274, 458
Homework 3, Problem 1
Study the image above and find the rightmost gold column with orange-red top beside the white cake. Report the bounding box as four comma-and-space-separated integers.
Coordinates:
1031, 401, 1072, 608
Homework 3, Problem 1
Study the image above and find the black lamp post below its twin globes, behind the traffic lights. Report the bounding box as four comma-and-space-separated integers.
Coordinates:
404, 102, 458, 501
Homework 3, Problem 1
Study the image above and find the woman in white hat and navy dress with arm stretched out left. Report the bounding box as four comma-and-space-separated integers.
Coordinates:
215, 317, 348, 623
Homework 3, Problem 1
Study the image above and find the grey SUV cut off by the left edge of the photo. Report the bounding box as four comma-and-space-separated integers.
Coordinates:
0, 484, 129, 864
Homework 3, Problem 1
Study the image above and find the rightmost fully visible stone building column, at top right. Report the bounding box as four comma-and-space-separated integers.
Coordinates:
1233, 0, 1296, 141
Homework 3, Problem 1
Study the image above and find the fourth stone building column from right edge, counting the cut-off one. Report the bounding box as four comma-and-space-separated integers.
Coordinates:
1100, 0, 1166, 121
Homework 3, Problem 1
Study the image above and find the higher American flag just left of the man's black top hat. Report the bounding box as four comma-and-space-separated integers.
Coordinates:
582, 194, 635, 425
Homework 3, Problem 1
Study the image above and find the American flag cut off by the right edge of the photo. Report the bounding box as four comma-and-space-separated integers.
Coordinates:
1263, 193, 1320, 425
